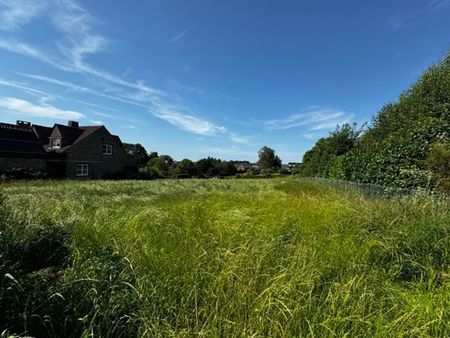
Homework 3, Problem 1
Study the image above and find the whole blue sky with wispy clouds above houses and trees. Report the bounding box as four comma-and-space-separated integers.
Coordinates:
0, 0, 450, 162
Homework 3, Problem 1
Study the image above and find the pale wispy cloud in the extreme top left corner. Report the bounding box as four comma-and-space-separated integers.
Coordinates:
0, 0, 47, 31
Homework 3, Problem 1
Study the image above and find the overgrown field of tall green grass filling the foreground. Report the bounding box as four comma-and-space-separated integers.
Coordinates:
0, 178, 450, 337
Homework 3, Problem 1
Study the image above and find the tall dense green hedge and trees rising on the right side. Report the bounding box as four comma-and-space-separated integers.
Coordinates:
302, 54, 450, 190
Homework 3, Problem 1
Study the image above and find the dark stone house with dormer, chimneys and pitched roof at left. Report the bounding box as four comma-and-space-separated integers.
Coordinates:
0, 121, 136, 178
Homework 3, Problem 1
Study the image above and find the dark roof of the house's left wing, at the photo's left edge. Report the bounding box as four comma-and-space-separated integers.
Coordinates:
0, 123, 45, 155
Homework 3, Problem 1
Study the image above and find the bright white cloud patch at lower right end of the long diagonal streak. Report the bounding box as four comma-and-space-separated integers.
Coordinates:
152, 109, 226, 136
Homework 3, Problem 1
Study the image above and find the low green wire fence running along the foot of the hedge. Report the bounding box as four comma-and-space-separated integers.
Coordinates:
300, 177, 449, 200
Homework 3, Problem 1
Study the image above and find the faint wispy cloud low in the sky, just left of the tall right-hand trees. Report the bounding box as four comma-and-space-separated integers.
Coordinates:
264, 107, 354, 131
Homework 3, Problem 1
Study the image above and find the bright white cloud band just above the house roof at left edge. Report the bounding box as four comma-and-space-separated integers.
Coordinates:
0, 97, 85, 120
